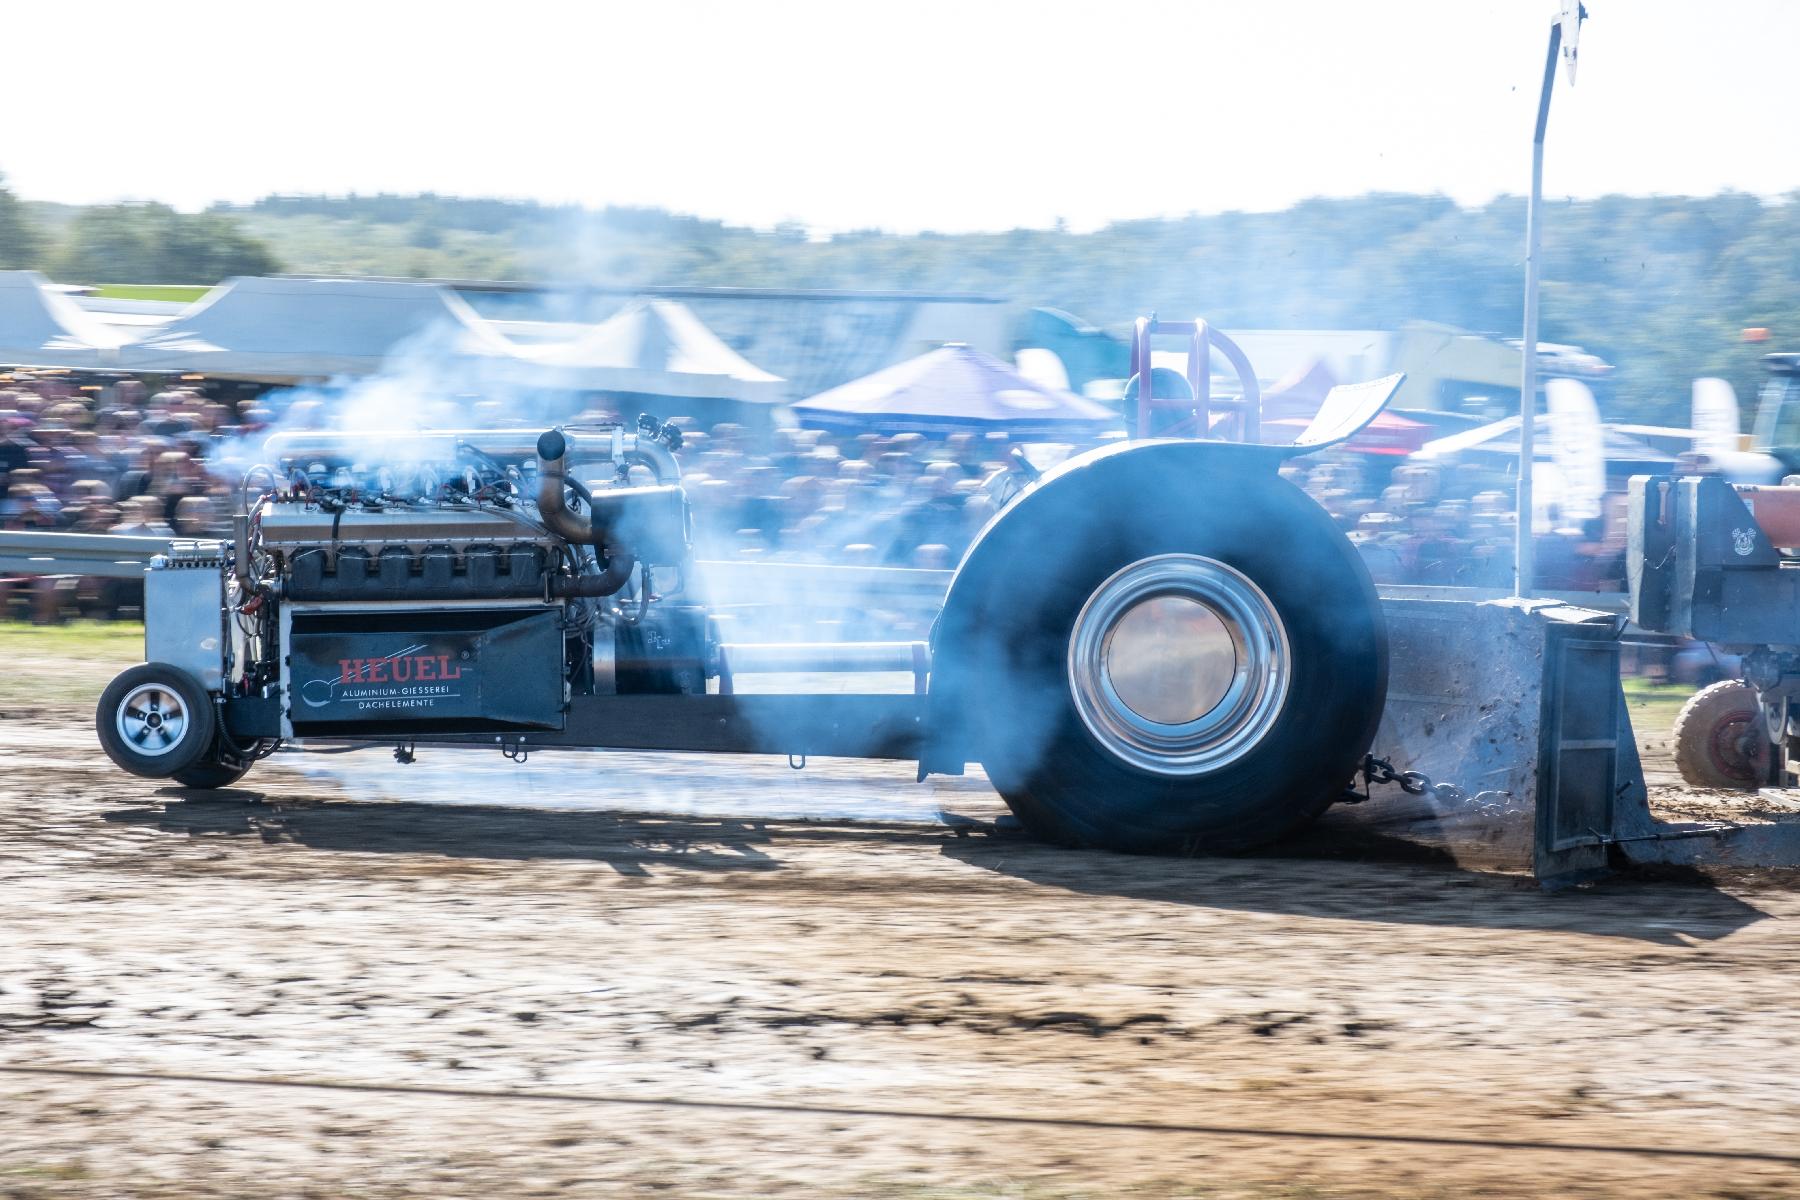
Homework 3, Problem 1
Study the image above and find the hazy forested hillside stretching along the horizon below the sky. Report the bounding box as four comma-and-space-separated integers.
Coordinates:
0, 182, 1800, 421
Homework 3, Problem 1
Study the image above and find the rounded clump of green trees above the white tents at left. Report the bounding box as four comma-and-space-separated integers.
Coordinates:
52, 203, 279, 284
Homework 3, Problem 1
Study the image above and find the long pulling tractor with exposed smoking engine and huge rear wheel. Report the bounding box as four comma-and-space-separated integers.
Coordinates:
97, 320, 1402, 851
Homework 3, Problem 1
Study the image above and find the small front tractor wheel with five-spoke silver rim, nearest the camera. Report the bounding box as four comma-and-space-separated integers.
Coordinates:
94, 662, 214, 779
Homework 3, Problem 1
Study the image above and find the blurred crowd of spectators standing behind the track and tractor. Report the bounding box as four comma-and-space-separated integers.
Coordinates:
0, 372, 1624, 621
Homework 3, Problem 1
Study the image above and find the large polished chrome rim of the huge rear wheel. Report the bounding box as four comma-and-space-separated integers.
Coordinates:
1069, 554, 1291, 775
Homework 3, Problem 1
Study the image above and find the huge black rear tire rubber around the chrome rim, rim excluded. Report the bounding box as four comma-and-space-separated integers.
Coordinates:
979, 471, 1386, 853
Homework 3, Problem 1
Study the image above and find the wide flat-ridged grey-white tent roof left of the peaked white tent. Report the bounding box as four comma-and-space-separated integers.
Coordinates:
119, 277, 513, 381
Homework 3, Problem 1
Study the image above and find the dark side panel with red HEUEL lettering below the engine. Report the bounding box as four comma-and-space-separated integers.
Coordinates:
288, 608, 563, 738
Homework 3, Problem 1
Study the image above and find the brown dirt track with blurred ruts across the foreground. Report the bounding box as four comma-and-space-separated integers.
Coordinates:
0, 716, 1800, 1196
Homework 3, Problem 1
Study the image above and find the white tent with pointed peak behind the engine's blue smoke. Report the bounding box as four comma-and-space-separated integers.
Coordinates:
509, 300, 787, 405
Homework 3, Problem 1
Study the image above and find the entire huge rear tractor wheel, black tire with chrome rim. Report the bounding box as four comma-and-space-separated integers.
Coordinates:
977, 470, 1388, 855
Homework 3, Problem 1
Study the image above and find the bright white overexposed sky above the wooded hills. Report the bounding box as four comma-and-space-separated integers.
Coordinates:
0, 0, 1800, 230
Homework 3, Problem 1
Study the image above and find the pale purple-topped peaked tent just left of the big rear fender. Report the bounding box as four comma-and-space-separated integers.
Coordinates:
794, 342, 1120, 441
